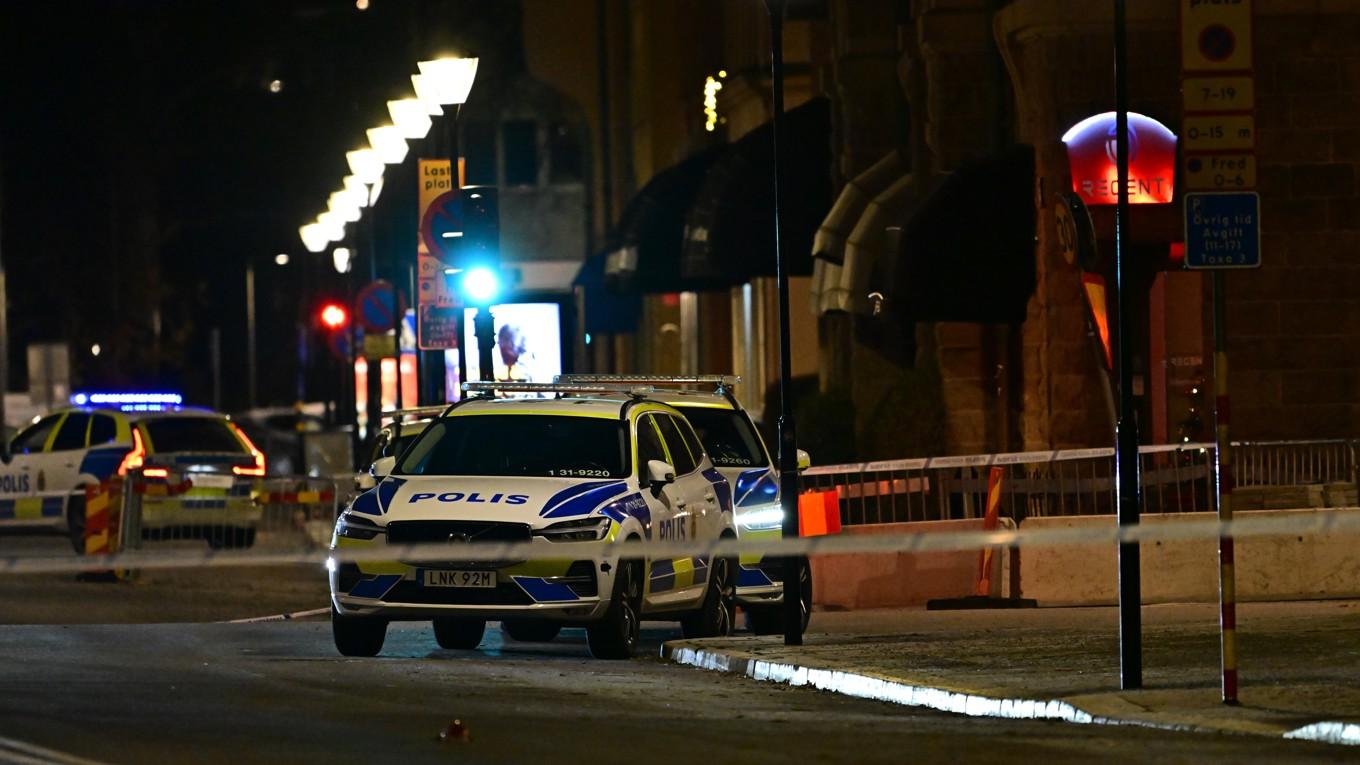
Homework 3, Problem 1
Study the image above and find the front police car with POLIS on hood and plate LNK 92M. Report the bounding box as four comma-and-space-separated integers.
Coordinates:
328, 383, 736, 659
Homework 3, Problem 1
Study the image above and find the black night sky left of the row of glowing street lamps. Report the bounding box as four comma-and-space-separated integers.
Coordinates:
0, 0, 518, 408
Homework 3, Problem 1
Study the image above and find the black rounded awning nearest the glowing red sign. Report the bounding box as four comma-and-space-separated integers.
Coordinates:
895, 146, 1038, 323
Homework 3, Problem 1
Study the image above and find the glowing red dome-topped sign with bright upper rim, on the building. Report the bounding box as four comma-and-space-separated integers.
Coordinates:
1062, 112, 1176, 204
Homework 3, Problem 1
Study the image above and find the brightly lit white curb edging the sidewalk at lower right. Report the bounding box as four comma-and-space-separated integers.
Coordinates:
661, 641, 1360, 746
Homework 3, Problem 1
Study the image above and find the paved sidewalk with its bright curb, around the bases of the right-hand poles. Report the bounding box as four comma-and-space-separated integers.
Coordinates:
661, 600, 1360, 745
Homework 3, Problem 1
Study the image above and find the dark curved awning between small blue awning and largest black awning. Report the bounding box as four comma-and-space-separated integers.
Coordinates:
604, 146, 728, 293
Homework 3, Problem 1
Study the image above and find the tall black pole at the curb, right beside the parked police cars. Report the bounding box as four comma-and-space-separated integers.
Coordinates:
766, 0, 802, 645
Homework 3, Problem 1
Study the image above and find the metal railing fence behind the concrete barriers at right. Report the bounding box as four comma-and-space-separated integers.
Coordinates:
802, 440, 1360, 525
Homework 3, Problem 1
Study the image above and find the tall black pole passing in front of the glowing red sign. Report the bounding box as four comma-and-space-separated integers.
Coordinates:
1114, 0, 1142, 690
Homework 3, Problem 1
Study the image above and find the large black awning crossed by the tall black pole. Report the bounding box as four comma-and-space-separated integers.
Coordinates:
680, 98, 832, 286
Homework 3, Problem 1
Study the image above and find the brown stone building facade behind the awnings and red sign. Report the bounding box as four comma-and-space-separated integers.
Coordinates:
524, 0, 1360, 459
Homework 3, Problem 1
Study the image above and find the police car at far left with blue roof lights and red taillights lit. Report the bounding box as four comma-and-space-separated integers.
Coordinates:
0, 393, 265, 553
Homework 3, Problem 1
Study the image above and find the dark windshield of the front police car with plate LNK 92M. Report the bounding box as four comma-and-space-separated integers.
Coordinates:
394, 414, 628, 478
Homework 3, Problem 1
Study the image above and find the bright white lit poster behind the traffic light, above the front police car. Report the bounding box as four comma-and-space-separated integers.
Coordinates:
462, 302, 562, 383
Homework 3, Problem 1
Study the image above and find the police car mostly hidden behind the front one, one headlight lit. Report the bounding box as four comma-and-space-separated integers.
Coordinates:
558, 374, 812, 634
